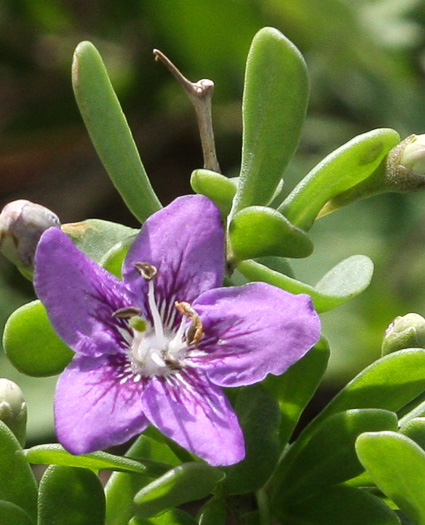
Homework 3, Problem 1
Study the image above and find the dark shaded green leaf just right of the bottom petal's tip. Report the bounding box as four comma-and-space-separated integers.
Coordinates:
222, 385, 280, 494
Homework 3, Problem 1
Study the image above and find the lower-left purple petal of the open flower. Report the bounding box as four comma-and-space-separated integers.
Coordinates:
55, 356, 148, 454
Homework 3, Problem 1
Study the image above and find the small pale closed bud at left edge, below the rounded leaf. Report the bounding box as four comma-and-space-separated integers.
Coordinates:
0, 378, 27, 446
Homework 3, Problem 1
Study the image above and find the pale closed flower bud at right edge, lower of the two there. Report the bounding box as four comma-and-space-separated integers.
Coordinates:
382, 313, 425, 355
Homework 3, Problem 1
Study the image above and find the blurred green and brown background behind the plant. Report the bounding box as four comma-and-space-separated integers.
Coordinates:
0, 0, 425, 442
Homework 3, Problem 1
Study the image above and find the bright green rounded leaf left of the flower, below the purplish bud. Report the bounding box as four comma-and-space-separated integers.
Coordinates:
3, 301, 74, 377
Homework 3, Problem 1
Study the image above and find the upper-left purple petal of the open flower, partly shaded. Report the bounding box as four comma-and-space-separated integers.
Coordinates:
34, 228, 131, 356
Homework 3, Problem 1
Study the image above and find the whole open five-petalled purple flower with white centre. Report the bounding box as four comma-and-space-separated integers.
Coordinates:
35, 195, 320, 465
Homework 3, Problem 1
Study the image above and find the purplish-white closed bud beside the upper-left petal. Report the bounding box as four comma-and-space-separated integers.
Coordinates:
0, 199, 60, 272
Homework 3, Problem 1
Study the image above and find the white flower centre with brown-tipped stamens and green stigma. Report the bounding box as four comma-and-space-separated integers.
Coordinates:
113, 263, 203, 377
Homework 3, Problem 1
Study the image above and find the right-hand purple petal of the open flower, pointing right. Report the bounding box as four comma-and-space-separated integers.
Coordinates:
191, 283, 320, 387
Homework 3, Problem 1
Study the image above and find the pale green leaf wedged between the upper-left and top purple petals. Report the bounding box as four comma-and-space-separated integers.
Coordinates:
62, 219, 138, 264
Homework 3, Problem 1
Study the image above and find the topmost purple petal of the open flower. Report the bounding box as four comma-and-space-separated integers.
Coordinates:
123, 195, 224, 322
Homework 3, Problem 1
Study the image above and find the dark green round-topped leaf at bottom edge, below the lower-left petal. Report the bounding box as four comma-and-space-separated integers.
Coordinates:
37, 465, 105, 525
